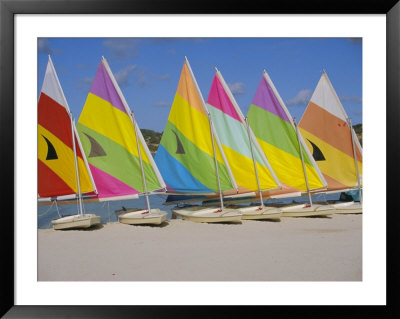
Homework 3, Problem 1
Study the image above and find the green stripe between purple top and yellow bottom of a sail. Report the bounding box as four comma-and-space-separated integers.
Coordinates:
247, 104, 314, 166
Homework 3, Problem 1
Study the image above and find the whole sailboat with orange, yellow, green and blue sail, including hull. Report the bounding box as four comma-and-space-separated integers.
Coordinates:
155, 57, 241, 223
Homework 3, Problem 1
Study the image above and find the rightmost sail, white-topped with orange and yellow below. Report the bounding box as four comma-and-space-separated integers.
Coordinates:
299, 72, 362, 191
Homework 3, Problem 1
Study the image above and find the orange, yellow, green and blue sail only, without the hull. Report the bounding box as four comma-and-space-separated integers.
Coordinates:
155, 60, 236, 194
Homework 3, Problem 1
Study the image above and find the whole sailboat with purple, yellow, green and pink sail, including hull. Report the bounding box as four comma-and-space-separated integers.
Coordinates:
77, 57, 167, 224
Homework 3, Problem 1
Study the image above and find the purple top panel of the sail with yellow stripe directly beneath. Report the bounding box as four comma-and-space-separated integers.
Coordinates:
90, 62, 125, 112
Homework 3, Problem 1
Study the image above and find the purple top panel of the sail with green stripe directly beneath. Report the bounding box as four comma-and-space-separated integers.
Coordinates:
252, 77, 290, 122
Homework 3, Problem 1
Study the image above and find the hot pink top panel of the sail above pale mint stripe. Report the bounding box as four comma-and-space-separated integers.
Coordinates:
207, 75, 242, 122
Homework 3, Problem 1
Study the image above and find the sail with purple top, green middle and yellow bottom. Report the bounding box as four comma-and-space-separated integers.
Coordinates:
247, 71, 326, 195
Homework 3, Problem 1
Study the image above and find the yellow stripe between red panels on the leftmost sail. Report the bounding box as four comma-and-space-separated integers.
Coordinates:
38, 125, 93, 193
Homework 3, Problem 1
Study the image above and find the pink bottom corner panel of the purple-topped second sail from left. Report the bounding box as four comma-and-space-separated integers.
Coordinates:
89, 164, 139, 198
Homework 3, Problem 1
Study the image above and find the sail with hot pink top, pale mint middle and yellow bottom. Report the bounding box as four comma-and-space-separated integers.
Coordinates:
206, 71, 280, 194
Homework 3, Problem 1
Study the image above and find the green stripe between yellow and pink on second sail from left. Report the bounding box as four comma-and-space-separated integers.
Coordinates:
77, 122, 162, 193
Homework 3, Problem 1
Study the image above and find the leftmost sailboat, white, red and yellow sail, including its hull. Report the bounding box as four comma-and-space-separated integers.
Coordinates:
38, 56, 100, 230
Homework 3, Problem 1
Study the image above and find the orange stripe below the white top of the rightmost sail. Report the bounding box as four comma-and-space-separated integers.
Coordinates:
301, 101, 362, 162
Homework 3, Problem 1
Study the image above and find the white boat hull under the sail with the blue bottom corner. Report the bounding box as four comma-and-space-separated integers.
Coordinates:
172, 206, 242, 223
